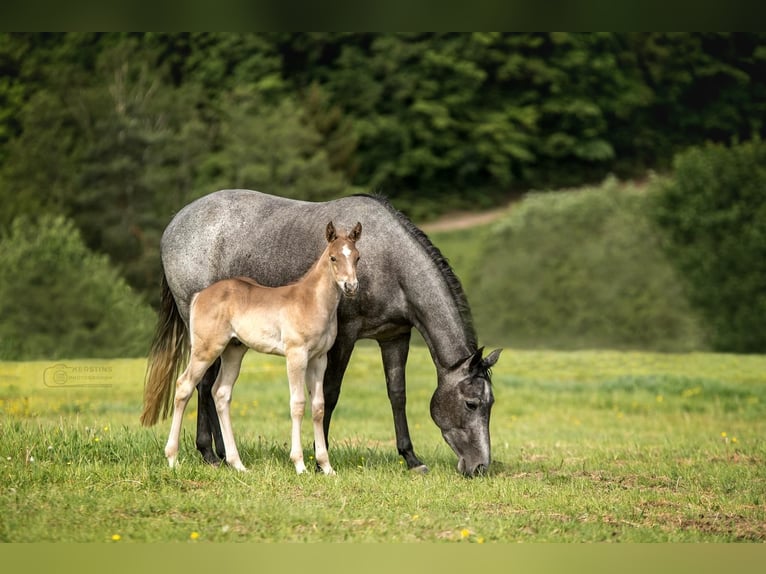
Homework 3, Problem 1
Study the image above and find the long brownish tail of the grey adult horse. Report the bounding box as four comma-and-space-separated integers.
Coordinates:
141, 272, 189, 427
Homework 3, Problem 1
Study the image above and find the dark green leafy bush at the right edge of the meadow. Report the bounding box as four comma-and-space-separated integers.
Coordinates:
656, 141, 766, 353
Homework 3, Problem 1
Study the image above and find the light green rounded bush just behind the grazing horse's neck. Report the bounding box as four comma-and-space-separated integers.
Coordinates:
465, 181, 704, 351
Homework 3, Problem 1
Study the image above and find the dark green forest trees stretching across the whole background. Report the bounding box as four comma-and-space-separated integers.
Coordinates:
0, 32, 766, 358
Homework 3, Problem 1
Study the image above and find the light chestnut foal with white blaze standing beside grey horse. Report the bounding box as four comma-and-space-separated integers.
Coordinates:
165, 222, 362, 474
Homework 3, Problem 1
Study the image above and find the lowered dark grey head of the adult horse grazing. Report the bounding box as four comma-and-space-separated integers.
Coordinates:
431, 348, 500, 476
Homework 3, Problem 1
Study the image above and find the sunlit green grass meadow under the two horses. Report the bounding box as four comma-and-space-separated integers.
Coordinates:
0, 345, 766, 544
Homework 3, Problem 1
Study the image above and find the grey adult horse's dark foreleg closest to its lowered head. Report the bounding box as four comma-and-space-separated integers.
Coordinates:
379, 332, 428, 472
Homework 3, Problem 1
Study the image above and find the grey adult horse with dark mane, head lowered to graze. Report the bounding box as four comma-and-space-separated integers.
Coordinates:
142, 190, 500, 476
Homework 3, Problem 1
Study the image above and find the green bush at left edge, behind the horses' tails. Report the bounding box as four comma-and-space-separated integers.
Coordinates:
0, 215, 154, 360
